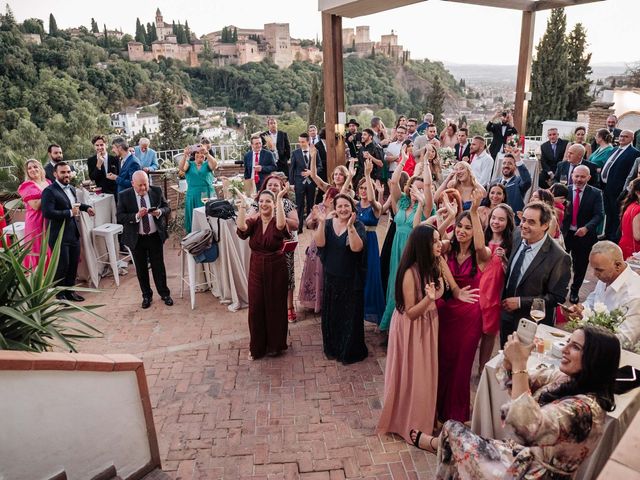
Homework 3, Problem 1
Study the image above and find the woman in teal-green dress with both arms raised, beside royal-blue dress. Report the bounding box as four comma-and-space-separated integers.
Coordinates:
380, 145, 433, 332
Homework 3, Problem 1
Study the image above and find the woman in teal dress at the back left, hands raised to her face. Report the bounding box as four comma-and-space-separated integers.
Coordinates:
178, 145, 218, 233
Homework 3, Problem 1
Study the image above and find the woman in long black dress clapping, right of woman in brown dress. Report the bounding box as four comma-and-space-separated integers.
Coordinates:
314, 194, 368, 364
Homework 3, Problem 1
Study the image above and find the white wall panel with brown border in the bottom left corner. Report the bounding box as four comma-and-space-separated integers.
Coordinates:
0, 371, 151, 480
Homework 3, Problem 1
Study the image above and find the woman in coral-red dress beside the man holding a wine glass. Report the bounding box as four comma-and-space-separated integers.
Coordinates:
478, 203, 515, 376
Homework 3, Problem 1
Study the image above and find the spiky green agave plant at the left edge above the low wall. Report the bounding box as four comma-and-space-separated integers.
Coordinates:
0, 231, 102, 352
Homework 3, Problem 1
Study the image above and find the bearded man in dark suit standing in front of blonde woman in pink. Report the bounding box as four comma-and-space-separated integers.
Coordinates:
42, 160, 95, 302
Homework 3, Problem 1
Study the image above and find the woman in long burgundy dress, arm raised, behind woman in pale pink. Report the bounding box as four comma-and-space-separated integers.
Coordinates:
437, 189, 491, 422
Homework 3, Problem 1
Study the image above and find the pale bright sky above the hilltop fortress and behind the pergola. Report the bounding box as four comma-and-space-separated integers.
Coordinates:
6, 0, 640, 65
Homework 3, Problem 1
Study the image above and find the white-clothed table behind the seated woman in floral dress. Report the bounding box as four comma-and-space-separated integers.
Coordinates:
471, 324, 640, 480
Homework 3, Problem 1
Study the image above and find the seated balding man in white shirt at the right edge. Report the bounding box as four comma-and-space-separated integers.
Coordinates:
568, 240, 640, 350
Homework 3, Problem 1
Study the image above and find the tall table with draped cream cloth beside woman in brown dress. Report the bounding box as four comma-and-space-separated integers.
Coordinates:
191, 207, 251, 312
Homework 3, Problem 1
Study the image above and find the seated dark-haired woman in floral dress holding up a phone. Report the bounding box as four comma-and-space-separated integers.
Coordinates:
411, 326, 620, 480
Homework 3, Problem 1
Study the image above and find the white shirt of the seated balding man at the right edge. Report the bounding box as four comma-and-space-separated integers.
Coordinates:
584, 265, 640, 349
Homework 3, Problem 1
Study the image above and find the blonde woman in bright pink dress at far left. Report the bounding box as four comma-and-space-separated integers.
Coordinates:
18, 159, 51, 268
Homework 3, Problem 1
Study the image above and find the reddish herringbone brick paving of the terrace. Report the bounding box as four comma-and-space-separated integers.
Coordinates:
79, 216, 596, 480
